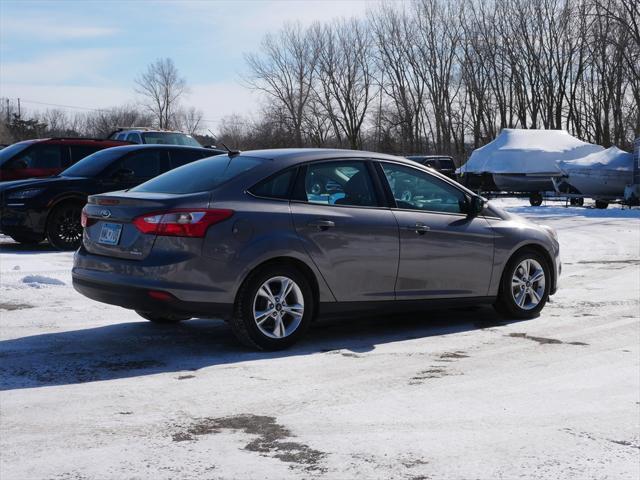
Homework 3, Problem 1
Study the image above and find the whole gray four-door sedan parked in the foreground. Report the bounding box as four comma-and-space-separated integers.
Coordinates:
73, 149, 560, 349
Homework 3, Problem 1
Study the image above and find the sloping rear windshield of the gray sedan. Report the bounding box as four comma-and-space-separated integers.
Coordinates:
131, 155, 264, 194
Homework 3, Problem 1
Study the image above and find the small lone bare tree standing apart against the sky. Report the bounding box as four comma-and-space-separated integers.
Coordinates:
135, 58, 188, 128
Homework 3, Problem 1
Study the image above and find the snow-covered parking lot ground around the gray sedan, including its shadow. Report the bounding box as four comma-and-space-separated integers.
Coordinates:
0, 200, 640, 480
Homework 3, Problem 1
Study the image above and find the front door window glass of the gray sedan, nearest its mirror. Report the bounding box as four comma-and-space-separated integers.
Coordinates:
382, 163, 467, 213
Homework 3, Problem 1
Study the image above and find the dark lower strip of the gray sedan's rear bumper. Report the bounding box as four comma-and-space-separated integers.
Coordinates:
73, 274, 233, 318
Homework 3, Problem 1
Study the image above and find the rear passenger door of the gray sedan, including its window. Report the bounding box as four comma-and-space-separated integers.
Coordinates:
291, 160, 399, 302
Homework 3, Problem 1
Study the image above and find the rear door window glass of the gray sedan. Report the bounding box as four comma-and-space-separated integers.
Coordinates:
296, 160, 378, 207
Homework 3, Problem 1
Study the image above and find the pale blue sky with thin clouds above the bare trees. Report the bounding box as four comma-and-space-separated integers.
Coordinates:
0, 0, 372, 128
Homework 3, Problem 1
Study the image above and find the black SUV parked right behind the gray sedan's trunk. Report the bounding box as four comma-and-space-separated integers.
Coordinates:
0, 145, 222, 249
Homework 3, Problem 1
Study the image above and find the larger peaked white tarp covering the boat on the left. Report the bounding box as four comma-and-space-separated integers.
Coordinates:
458, 128, 604, 174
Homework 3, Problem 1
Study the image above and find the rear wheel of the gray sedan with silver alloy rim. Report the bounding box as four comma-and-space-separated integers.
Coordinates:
229, 265, 315, 350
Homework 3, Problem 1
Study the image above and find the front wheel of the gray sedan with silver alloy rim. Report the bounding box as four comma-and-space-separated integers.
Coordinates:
494, 250, 551, 320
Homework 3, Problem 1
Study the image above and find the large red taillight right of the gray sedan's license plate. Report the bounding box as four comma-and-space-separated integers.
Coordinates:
133, 209, 233, 237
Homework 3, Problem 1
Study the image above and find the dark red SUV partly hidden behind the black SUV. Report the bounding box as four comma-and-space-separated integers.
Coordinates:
0, 138, 130, 181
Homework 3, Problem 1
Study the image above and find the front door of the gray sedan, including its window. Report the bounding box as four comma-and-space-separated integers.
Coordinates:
378, 162, 494, 300
